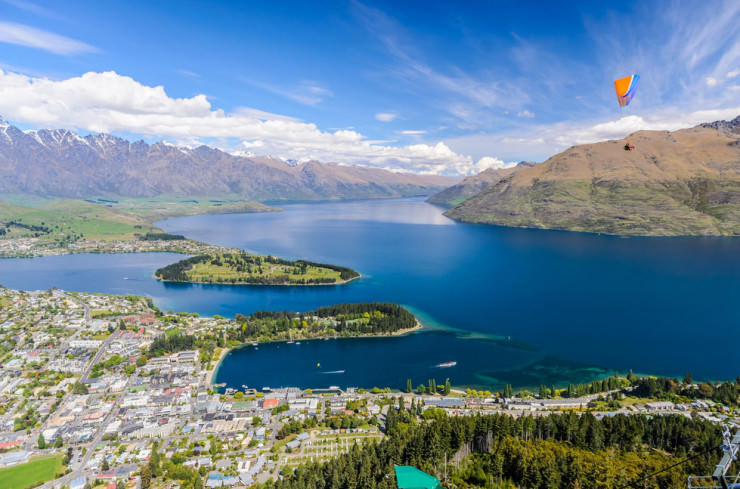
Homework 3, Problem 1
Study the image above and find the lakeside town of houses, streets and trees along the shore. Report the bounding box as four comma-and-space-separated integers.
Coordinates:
0, 288, 738, 489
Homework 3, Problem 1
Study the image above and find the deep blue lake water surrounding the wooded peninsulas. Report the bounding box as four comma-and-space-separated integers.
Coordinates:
0, 199, 740, 388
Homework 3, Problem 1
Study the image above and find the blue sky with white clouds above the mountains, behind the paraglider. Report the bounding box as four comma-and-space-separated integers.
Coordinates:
0, 0, 740, 175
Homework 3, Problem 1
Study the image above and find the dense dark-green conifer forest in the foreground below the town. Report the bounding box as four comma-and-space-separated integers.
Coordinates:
263, 406, 721, 489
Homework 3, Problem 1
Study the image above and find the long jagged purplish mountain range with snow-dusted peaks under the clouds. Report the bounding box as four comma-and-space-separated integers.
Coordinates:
0, 119, 454, 200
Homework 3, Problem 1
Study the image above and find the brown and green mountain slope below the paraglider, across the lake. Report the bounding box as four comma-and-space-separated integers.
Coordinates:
447, 117, 740, 235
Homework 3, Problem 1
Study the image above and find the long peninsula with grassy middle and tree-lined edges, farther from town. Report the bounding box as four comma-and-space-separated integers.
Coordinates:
154, 252, 360, 285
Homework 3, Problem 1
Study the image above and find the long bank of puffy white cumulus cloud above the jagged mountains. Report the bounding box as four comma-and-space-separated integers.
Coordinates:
0, 70, 502, 175
